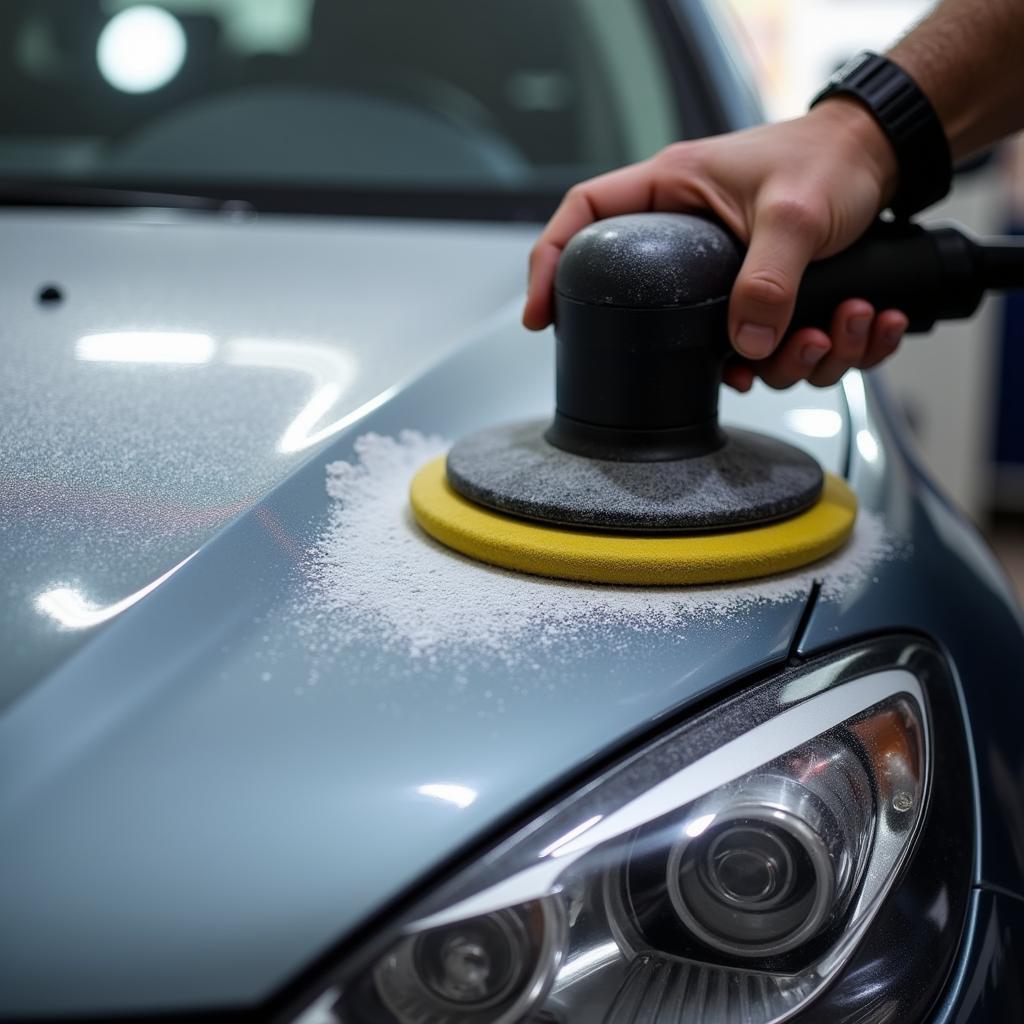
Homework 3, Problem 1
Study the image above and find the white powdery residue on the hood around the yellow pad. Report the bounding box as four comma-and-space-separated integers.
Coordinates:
304, 431, 896, 662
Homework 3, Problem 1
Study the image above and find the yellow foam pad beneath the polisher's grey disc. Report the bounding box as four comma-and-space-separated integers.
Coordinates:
410, 456, 857, 587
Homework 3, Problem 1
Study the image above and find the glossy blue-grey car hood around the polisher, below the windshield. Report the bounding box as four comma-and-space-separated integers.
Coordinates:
0, 207, 847, 1016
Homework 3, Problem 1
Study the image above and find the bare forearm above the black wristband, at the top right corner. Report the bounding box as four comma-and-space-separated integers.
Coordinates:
888, 0, 1024, 159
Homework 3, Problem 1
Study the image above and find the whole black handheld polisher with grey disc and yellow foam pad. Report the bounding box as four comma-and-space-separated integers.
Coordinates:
411, 213, 1024, 586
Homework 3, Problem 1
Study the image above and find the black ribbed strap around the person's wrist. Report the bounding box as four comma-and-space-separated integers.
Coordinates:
811, 51, 953, 218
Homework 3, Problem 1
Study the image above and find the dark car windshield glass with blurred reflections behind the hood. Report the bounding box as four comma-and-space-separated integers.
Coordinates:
0, 0, 687, 211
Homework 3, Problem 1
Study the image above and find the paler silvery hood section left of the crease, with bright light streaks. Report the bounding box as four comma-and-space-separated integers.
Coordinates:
0, 211, 532, 710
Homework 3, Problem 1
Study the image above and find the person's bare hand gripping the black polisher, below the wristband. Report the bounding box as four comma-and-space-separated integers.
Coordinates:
522, 98, 908, 391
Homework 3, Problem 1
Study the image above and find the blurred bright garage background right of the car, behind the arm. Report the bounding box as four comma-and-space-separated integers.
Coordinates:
728, 0, 1024, 599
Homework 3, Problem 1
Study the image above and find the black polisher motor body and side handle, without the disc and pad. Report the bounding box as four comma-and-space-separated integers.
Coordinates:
546, 213, 1024, 462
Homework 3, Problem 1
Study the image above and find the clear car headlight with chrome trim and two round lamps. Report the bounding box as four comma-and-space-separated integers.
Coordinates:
294, 641, 971, 1024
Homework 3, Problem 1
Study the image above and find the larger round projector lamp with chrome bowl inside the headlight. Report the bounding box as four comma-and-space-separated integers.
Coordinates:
659, 739, 873, 959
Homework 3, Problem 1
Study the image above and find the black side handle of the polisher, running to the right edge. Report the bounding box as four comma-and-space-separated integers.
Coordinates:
792, 221, 1024, 332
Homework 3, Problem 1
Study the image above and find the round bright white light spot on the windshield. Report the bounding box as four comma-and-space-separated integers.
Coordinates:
96, 4, 187, 93
